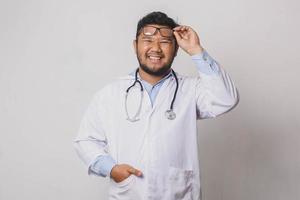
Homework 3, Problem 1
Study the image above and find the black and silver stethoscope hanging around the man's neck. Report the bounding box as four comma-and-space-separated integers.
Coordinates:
125, 68, 178, 122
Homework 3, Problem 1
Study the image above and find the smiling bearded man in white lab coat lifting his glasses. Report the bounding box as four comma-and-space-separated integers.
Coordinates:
74, 12, 238, 200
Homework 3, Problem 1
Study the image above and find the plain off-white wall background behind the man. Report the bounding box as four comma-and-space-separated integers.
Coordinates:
0, 0, 300, 200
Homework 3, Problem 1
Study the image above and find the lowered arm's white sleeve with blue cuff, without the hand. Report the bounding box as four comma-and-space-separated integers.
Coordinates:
73, 93, 115, 177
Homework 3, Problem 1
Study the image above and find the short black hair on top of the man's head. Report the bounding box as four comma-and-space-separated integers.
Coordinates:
136, 11, 179, 39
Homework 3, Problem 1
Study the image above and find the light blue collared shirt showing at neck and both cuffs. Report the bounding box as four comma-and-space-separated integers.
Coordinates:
90, 50, 220, 177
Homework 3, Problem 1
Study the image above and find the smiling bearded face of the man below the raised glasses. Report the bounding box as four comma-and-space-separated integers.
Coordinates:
133, 24, 177, 76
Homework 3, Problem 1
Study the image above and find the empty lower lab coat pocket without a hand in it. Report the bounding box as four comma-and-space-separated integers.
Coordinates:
166, 167, 195, 200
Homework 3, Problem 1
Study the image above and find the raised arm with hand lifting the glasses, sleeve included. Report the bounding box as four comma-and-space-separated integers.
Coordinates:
174, 26, 239, 119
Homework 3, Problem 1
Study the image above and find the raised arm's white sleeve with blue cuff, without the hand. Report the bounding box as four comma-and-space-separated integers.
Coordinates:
192, 50, 239, 119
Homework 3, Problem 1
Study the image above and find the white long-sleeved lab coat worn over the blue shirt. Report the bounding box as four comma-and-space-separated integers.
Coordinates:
74, 65, 238, 200
